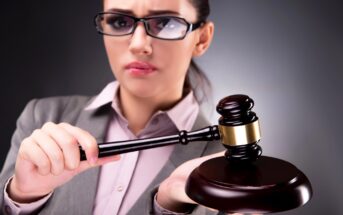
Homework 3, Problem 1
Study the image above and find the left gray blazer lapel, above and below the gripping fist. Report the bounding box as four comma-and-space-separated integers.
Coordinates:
42, 105, 111, 214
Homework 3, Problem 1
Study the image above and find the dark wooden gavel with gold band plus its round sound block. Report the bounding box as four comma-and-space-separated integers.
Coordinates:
80, 95, 312, 213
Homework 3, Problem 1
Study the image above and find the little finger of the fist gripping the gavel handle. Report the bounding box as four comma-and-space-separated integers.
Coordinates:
18, 138, 51, 175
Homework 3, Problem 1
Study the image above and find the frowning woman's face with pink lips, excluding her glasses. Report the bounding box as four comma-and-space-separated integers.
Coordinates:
104, 0, 206, 101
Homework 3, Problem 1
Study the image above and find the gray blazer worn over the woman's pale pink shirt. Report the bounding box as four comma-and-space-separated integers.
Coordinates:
0, 96, 224, 215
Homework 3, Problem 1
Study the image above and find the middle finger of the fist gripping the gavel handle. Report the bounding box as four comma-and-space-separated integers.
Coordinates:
42, 122, 80, 170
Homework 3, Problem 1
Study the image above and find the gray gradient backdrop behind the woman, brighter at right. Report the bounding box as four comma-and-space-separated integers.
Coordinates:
0, 0, 343, 214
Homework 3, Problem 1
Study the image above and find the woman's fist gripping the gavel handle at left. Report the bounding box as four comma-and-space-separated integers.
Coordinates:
7, 122, 120, 203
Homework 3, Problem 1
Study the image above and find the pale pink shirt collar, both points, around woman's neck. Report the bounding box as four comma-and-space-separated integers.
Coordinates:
85, 81, 199, 131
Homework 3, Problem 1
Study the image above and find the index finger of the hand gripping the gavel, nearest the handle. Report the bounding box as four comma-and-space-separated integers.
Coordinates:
59, 123, 99, 166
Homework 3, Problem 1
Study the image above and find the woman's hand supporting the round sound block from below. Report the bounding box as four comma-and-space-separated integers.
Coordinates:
157, 151, 224, 212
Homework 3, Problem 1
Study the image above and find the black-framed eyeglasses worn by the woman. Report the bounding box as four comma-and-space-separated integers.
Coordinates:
94, 12, 204, 40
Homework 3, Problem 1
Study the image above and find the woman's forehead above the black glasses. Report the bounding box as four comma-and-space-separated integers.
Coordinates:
104, 0, 196, 19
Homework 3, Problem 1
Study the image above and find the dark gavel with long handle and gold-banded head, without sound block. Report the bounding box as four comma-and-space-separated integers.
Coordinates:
80, 95, 261, 160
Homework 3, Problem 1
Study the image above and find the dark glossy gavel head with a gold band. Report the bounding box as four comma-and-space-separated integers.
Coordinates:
217, 94, 262, 162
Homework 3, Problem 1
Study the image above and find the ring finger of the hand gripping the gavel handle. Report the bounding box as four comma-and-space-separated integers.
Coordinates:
31, 129, 64, 175
